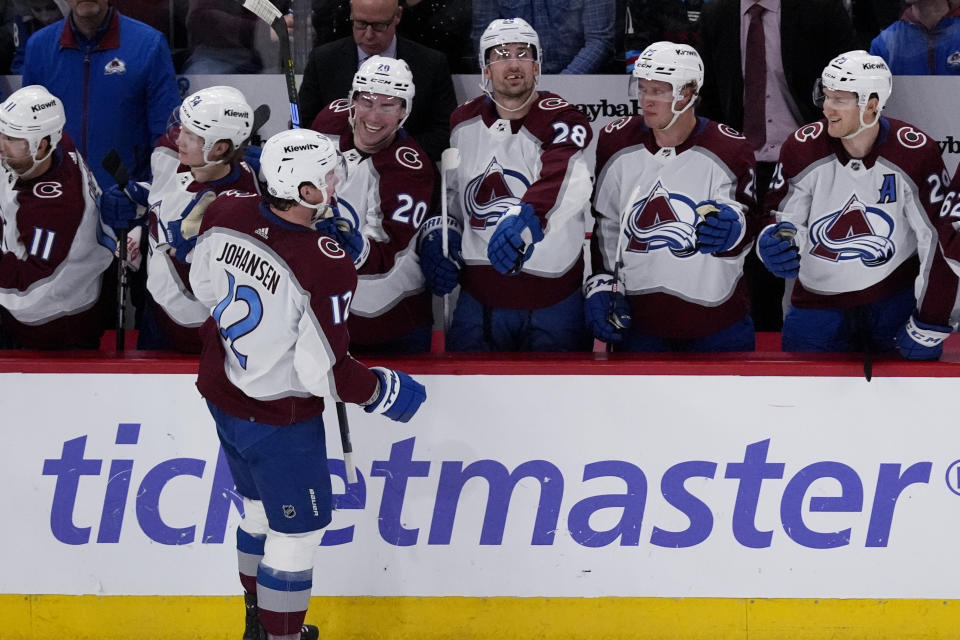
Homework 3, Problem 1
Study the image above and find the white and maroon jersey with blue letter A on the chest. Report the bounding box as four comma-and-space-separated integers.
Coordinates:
765, 118, 957, 326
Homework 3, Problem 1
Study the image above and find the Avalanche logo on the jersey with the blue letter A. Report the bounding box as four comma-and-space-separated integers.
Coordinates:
810, 194, 896, 267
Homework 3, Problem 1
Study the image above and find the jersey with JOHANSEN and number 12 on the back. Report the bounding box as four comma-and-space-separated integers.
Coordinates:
190, 193, 377, 425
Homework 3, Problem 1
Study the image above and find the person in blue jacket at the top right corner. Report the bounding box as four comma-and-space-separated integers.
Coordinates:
870, 0, 960, 76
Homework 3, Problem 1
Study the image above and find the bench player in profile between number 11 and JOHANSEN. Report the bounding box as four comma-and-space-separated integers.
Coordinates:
101, 86, 259, 353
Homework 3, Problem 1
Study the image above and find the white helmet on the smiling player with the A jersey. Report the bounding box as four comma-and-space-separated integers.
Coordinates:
814, 49, 893, 138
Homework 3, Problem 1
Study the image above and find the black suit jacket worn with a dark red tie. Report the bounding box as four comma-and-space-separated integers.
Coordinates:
697, 0, 854, 131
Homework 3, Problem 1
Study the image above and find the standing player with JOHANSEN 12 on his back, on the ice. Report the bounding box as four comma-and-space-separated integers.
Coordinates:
190, 129, 426, 640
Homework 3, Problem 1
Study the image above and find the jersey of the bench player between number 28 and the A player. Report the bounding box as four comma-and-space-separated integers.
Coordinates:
592, 117, 757, 338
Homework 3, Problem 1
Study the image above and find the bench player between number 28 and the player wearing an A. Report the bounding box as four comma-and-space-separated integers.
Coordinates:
584, 42, 757, 351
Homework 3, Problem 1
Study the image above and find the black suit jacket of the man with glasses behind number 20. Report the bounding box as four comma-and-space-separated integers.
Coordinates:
300, 36, 457, 162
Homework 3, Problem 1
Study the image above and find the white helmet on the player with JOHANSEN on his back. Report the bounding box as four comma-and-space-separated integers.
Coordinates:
260, 129, 347, 209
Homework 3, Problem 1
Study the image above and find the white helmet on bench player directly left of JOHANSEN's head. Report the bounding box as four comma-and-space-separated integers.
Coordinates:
178, 86, 253, 163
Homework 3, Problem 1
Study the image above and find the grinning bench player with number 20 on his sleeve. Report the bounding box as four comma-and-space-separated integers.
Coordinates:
311, 56, 434, 353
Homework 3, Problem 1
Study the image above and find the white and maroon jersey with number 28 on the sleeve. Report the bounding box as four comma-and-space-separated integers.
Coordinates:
445, 91, 593, 309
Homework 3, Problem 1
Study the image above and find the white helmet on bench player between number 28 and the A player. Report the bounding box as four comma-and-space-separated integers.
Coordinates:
629, 40, 703, 129
